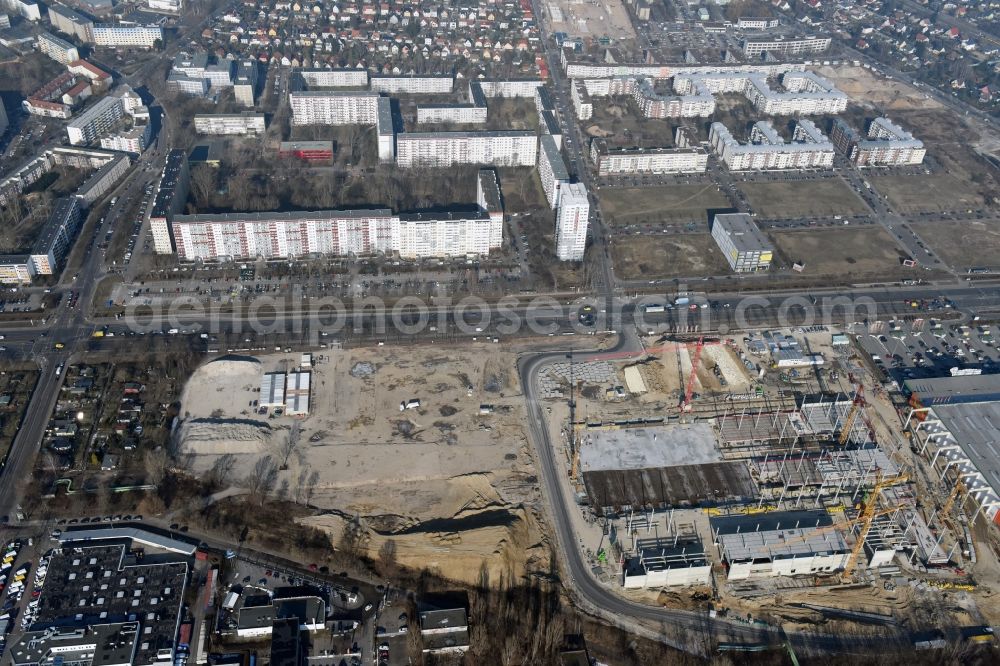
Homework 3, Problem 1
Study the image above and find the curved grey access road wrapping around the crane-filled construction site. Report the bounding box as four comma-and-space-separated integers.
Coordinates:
518, 335, 903, 655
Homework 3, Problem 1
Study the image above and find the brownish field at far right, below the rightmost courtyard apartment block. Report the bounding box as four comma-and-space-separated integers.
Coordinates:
868, 173, 985, 214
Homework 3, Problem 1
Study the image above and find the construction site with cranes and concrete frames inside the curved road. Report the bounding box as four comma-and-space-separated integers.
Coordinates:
540, 327, 1000, 642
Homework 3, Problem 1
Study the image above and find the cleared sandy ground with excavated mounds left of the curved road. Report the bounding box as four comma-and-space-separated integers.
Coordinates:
178, 344, 548, 581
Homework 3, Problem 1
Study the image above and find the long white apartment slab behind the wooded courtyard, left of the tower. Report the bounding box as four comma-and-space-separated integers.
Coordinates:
396, 131, 538, 168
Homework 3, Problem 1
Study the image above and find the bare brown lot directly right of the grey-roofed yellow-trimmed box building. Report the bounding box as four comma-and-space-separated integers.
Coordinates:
770, 227, 912, 281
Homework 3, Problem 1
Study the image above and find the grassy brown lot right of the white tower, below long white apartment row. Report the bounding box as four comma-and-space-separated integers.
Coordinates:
598, 185, 730, 226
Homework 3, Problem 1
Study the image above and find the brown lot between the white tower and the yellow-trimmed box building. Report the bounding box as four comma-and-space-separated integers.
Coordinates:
611, 234, 729, 280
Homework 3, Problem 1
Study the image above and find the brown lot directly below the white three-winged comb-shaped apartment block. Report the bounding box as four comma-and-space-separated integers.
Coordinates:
738, 178, 869, 218
